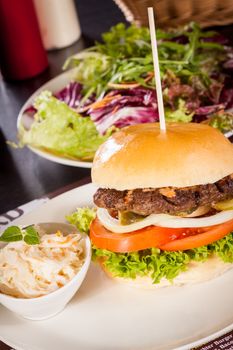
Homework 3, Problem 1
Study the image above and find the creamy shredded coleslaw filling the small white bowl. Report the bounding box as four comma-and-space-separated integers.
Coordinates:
0, 231, 85, 298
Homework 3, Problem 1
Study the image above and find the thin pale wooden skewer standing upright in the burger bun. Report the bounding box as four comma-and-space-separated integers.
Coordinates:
147, 7, 166, 131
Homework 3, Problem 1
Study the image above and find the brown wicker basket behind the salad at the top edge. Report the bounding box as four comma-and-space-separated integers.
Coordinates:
114, 0, 233, 27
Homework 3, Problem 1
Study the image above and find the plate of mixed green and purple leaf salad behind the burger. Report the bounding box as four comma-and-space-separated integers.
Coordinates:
18, 23, 233, 167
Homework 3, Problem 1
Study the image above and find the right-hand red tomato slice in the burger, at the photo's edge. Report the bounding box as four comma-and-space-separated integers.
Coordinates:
159, 220, 233, 251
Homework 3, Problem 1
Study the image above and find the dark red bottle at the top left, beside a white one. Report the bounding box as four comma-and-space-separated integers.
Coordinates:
0, 0, 48, 80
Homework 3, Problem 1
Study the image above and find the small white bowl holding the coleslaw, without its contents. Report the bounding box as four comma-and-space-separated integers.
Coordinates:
0, 224, 91, 321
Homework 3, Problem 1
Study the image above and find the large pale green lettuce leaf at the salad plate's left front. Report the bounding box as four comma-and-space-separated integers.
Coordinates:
19, 91, 109, 161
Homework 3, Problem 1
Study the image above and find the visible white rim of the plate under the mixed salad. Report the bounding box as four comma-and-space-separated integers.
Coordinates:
17, 69, 92, 168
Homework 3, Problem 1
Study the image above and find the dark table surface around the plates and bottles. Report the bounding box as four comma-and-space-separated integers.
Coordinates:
0, 0, 232, 350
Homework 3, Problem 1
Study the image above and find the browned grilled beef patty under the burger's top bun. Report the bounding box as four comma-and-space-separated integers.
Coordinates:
94, 174, 233, 215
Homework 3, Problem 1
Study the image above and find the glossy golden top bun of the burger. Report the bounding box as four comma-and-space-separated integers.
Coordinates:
92, 123, 233, 191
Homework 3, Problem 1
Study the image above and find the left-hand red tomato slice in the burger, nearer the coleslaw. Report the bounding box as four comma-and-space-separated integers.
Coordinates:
90, 218, 184, 253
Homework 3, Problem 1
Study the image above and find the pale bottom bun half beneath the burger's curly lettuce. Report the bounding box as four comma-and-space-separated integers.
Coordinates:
100, 256, 233, 289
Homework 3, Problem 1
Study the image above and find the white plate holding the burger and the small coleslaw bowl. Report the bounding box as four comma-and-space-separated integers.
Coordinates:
0, 184, 233, 350
